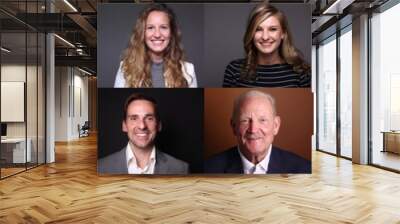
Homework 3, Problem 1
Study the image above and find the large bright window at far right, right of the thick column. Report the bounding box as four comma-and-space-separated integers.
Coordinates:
370, 1, 400, 170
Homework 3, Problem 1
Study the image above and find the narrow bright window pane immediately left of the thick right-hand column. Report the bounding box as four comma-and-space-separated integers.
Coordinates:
339, 25, 353, 158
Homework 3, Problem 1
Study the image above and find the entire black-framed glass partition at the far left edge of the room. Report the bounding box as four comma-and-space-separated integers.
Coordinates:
0, 1, 46, 178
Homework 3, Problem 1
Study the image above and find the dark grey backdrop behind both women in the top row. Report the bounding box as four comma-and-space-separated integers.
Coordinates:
97, 3, 311, 88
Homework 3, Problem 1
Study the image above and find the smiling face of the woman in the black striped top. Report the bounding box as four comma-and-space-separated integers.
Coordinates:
253, 16, 285, 59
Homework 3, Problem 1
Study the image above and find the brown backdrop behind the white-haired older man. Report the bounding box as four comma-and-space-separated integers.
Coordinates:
204, 88, 313, 160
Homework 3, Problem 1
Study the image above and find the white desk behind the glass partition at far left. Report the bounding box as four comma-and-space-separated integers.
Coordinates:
1, 138, 32, 163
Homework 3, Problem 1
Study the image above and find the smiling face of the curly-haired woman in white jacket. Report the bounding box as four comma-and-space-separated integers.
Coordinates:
144, 11, 171, 61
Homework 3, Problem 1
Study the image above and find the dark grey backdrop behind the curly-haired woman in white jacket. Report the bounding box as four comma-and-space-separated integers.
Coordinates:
97, 3, 204, 88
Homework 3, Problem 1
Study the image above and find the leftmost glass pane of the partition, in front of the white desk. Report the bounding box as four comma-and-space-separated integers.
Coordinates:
1, 32, 30, 177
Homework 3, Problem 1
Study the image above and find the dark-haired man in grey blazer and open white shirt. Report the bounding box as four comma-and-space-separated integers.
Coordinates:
98, 94, 189, 174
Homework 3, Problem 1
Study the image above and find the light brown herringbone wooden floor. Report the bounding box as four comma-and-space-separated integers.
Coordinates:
0, 134, 400, 224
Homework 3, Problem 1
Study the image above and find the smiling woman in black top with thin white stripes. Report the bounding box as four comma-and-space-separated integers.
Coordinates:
223, 3, 311, 87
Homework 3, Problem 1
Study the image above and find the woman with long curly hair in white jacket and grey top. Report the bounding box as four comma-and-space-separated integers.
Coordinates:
114, 4, 197, 88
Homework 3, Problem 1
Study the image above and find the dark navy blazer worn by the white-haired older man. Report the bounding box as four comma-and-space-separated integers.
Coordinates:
204, 146, 311, 173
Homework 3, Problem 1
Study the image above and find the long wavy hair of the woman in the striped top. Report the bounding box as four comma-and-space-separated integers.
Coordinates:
240, 2, 310, 80
